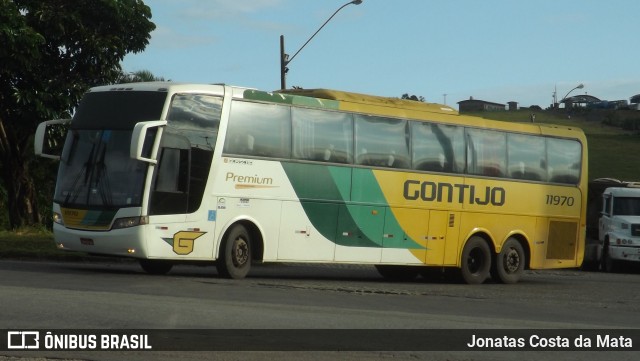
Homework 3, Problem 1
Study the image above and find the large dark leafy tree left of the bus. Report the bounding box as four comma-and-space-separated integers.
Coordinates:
0, 0, 155, 228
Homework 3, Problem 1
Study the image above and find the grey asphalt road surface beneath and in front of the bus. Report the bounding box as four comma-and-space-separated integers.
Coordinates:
0, 260, 640, 361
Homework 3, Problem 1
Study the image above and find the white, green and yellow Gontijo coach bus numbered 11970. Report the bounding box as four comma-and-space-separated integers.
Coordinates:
34, 82, 587, 284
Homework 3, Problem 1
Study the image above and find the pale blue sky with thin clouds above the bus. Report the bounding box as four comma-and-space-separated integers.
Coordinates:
122, 0, 640, 108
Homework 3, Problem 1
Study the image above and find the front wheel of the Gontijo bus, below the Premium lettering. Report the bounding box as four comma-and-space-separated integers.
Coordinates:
216, 224, 251, 279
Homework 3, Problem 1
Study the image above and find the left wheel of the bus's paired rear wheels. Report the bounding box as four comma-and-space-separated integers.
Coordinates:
460, 236, 491, 285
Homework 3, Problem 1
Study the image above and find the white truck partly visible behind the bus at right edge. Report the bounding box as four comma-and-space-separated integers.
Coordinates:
597, 183, 640, 272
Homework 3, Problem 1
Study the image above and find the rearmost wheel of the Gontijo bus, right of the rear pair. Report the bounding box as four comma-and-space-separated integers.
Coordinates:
491, 238, 527, 284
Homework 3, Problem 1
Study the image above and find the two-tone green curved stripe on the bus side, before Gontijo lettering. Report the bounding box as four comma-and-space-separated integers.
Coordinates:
282, 162, 424, 249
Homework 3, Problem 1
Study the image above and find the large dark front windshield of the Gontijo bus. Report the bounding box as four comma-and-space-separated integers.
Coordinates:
54, 91, 167, 208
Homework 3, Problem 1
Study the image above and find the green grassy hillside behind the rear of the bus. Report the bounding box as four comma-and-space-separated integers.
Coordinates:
472, 109, 640, 181
